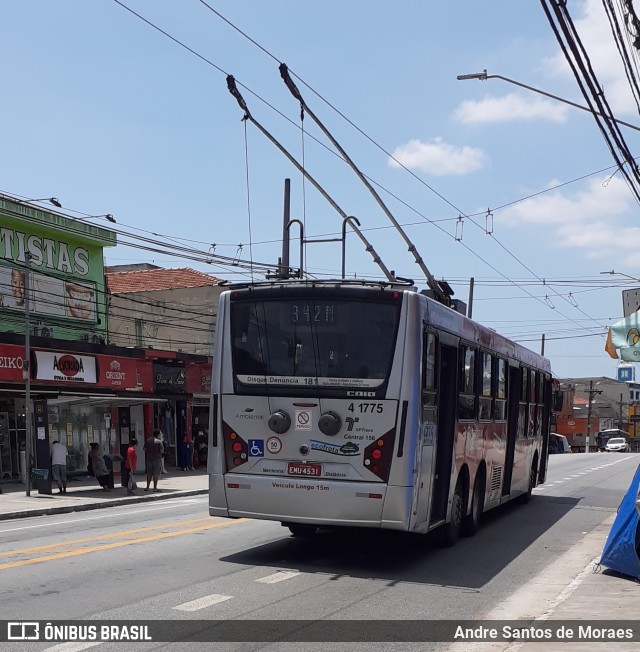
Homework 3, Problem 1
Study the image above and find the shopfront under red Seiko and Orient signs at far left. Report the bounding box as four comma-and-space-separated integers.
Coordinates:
0, 338, 155, 480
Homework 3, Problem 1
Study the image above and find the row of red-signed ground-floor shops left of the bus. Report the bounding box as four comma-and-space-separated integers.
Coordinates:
0, 334, 211, 482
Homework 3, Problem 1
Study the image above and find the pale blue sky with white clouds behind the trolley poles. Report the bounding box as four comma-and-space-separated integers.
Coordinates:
0, 0, 640, 378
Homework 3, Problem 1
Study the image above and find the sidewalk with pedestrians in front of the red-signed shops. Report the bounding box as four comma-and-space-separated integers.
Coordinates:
0, 469, 208, 521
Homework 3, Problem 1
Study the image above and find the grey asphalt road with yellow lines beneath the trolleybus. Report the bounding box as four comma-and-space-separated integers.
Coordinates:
0, 454, 640, 652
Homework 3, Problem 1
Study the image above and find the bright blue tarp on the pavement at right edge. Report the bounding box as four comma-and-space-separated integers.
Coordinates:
600, 466, 640, 579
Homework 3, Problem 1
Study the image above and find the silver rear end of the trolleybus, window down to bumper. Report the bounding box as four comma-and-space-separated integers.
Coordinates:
209, 283, 406, 531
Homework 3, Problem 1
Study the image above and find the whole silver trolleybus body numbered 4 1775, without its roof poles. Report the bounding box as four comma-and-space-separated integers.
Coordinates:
209, 280, 552, 545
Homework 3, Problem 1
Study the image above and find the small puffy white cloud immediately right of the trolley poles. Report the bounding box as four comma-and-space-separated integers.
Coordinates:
389, 138, 486, 176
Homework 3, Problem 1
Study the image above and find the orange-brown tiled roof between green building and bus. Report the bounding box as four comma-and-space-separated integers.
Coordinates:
105, 267, 222, 294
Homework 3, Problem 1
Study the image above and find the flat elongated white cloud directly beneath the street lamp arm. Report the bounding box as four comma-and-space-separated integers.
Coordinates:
454, 93, 567, 124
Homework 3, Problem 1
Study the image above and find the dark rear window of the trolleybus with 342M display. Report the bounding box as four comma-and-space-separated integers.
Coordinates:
231, 298, 400, 388
